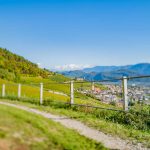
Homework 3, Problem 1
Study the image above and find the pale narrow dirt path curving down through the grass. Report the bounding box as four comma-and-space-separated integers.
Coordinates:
0, 102, 147, 150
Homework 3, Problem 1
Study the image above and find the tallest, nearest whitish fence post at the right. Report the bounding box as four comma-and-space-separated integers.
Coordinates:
122, 77, 128, 111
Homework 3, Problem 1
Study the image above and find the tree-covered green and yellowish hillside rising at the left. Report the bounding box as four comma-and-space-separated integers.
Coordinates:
0, 48, 67, 82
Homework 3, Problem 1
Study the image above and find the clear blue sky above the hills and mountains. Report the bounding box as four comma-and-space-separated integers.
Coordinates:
0, 0, 150, 68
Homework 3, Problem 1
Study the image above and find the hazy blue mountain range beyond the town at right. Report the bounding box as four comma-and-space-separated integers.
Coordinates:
62, 63, 150, 81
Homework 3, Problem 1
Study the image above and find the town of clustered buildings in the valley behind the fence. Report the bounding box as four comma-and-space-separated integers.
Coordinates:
78, 78, 150, 107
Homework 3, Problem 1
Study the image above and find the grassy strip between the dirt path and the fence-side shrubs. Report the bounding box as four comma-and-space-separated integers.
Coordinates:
1, 100, 150, 147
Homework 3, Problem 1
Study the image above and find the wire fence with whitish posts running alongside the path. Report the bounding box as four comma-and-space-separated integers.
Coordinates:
0, 76, 150, 111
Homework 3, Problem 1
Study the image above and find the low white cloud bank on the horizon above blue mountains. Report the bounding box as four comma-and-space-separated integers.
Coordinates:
54, 64, 91, 71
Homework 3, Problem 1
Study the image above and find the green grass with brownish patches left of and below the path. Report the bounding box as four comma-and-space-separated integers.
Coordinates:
0, 105, 106, 150
